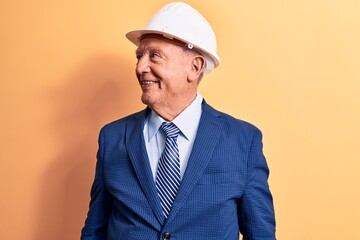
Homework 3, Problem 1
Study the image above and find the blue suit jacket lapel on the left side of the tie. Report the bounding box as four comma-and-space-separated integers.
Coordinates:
126, 109, 164, 224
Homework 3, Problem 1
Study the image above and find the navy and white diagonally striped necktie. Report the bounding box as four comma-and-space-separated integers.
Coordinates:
156, 122, 180, 218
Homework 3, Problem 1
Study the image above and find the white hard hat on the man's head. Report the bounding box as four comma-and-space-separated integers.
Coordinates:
126, 2, 220, 72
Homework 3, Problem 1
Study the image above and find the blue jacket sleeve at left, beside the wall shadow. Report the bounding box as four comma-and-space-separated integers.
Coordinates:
81, 130, 112, 240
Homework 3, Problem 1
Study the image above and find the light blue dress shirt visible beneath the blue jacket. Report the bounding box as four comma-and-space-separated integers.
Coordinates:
143, 93, 203, 181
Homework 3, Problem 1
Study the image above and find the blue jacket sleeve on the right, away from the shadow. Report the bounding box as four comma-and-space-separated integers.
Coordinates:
238, 129, 276, 240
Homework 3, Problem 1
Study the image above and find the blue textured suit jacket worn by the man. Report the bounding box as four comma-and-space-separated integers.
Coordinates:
81, 101, 275, 240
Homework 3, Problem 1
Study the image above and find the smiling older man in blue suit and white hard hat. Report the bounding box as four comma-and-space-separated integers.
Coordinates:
81, 3, 275, 240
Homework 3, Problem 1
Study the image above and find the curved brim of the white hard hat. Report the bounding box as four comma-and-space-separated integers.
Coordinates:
125, 30, 220, 68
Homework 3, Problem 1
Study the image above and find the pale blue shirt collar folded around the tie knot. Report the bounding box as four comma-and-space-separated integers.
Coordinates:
148, 92, 203, 141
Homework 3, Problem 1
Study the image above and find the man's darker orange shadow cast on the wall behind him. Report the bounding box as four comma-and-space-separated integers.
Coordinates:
34, 55, 144, 240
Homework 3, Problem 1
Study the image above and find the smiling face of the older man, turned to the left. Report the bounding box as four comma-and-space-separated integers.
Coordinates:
136, 37, 197, 116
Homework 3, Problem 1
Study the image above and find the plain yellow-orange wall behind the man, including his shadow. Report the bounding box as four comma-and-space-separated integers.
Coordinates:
0, 0, 360, 240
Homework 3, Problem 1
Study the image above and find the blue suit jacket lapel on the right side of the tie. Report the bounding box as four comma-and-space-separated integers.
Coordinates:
167, 101, 222, 223
